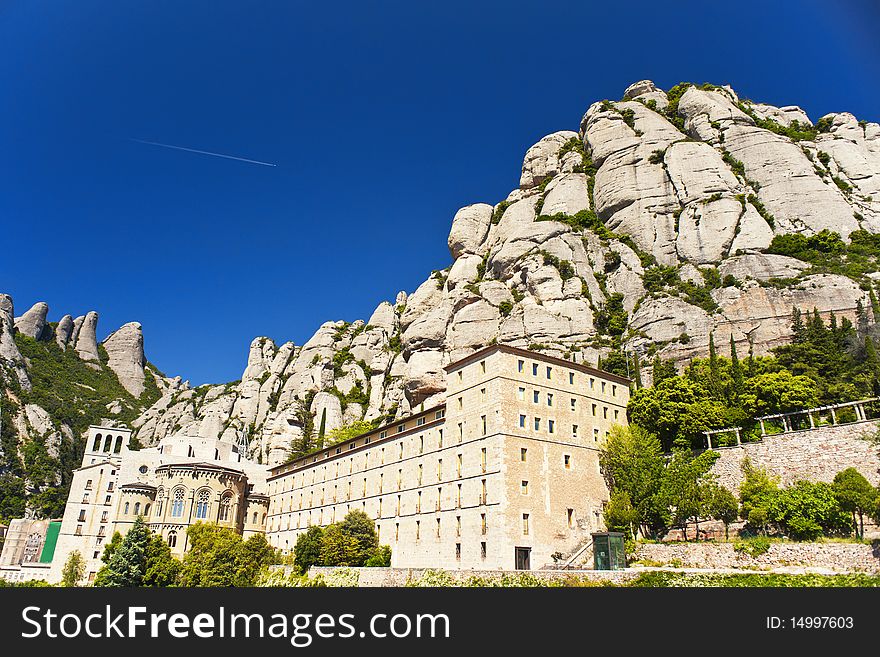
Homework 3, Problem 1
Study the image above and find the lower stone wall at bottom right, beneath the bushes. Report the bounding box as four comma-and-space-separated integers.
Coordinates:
633, 542, 880, 574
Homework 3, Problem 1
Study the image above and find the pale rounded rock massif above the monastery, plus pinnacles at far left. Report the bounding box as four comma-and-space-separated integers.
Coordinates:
0, 80, 880, 512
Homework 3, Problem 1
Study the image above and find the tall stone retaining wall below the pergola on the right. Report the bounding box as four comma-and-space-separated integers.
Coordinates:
713, 421, 880, 492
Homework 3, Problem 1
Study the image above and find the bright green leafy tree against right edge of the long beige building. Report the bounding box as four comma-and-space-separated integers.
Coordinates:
599, 424, 668, 537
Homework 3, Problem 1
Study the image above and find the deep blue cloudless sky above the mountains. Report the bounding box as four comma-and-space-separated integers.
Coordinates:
0, 0, 880, 383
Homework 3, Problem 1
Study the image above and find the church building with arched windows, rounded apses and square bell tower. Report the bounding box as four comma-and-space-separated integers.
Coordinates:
43, 427, 269, 582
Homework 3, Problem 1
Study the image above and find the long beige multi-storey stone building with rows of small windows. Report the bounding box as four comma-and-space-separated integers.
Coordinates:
267, 345, 629, 570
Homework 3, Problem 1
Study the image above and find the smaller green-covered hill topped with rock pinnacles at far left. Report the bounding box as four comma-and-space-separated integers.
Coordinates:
0, 294, 179, 518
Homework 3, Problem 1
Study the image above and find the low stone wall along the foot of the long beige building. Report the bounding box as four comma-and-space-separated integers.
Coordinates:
309, 566, 638, 587
